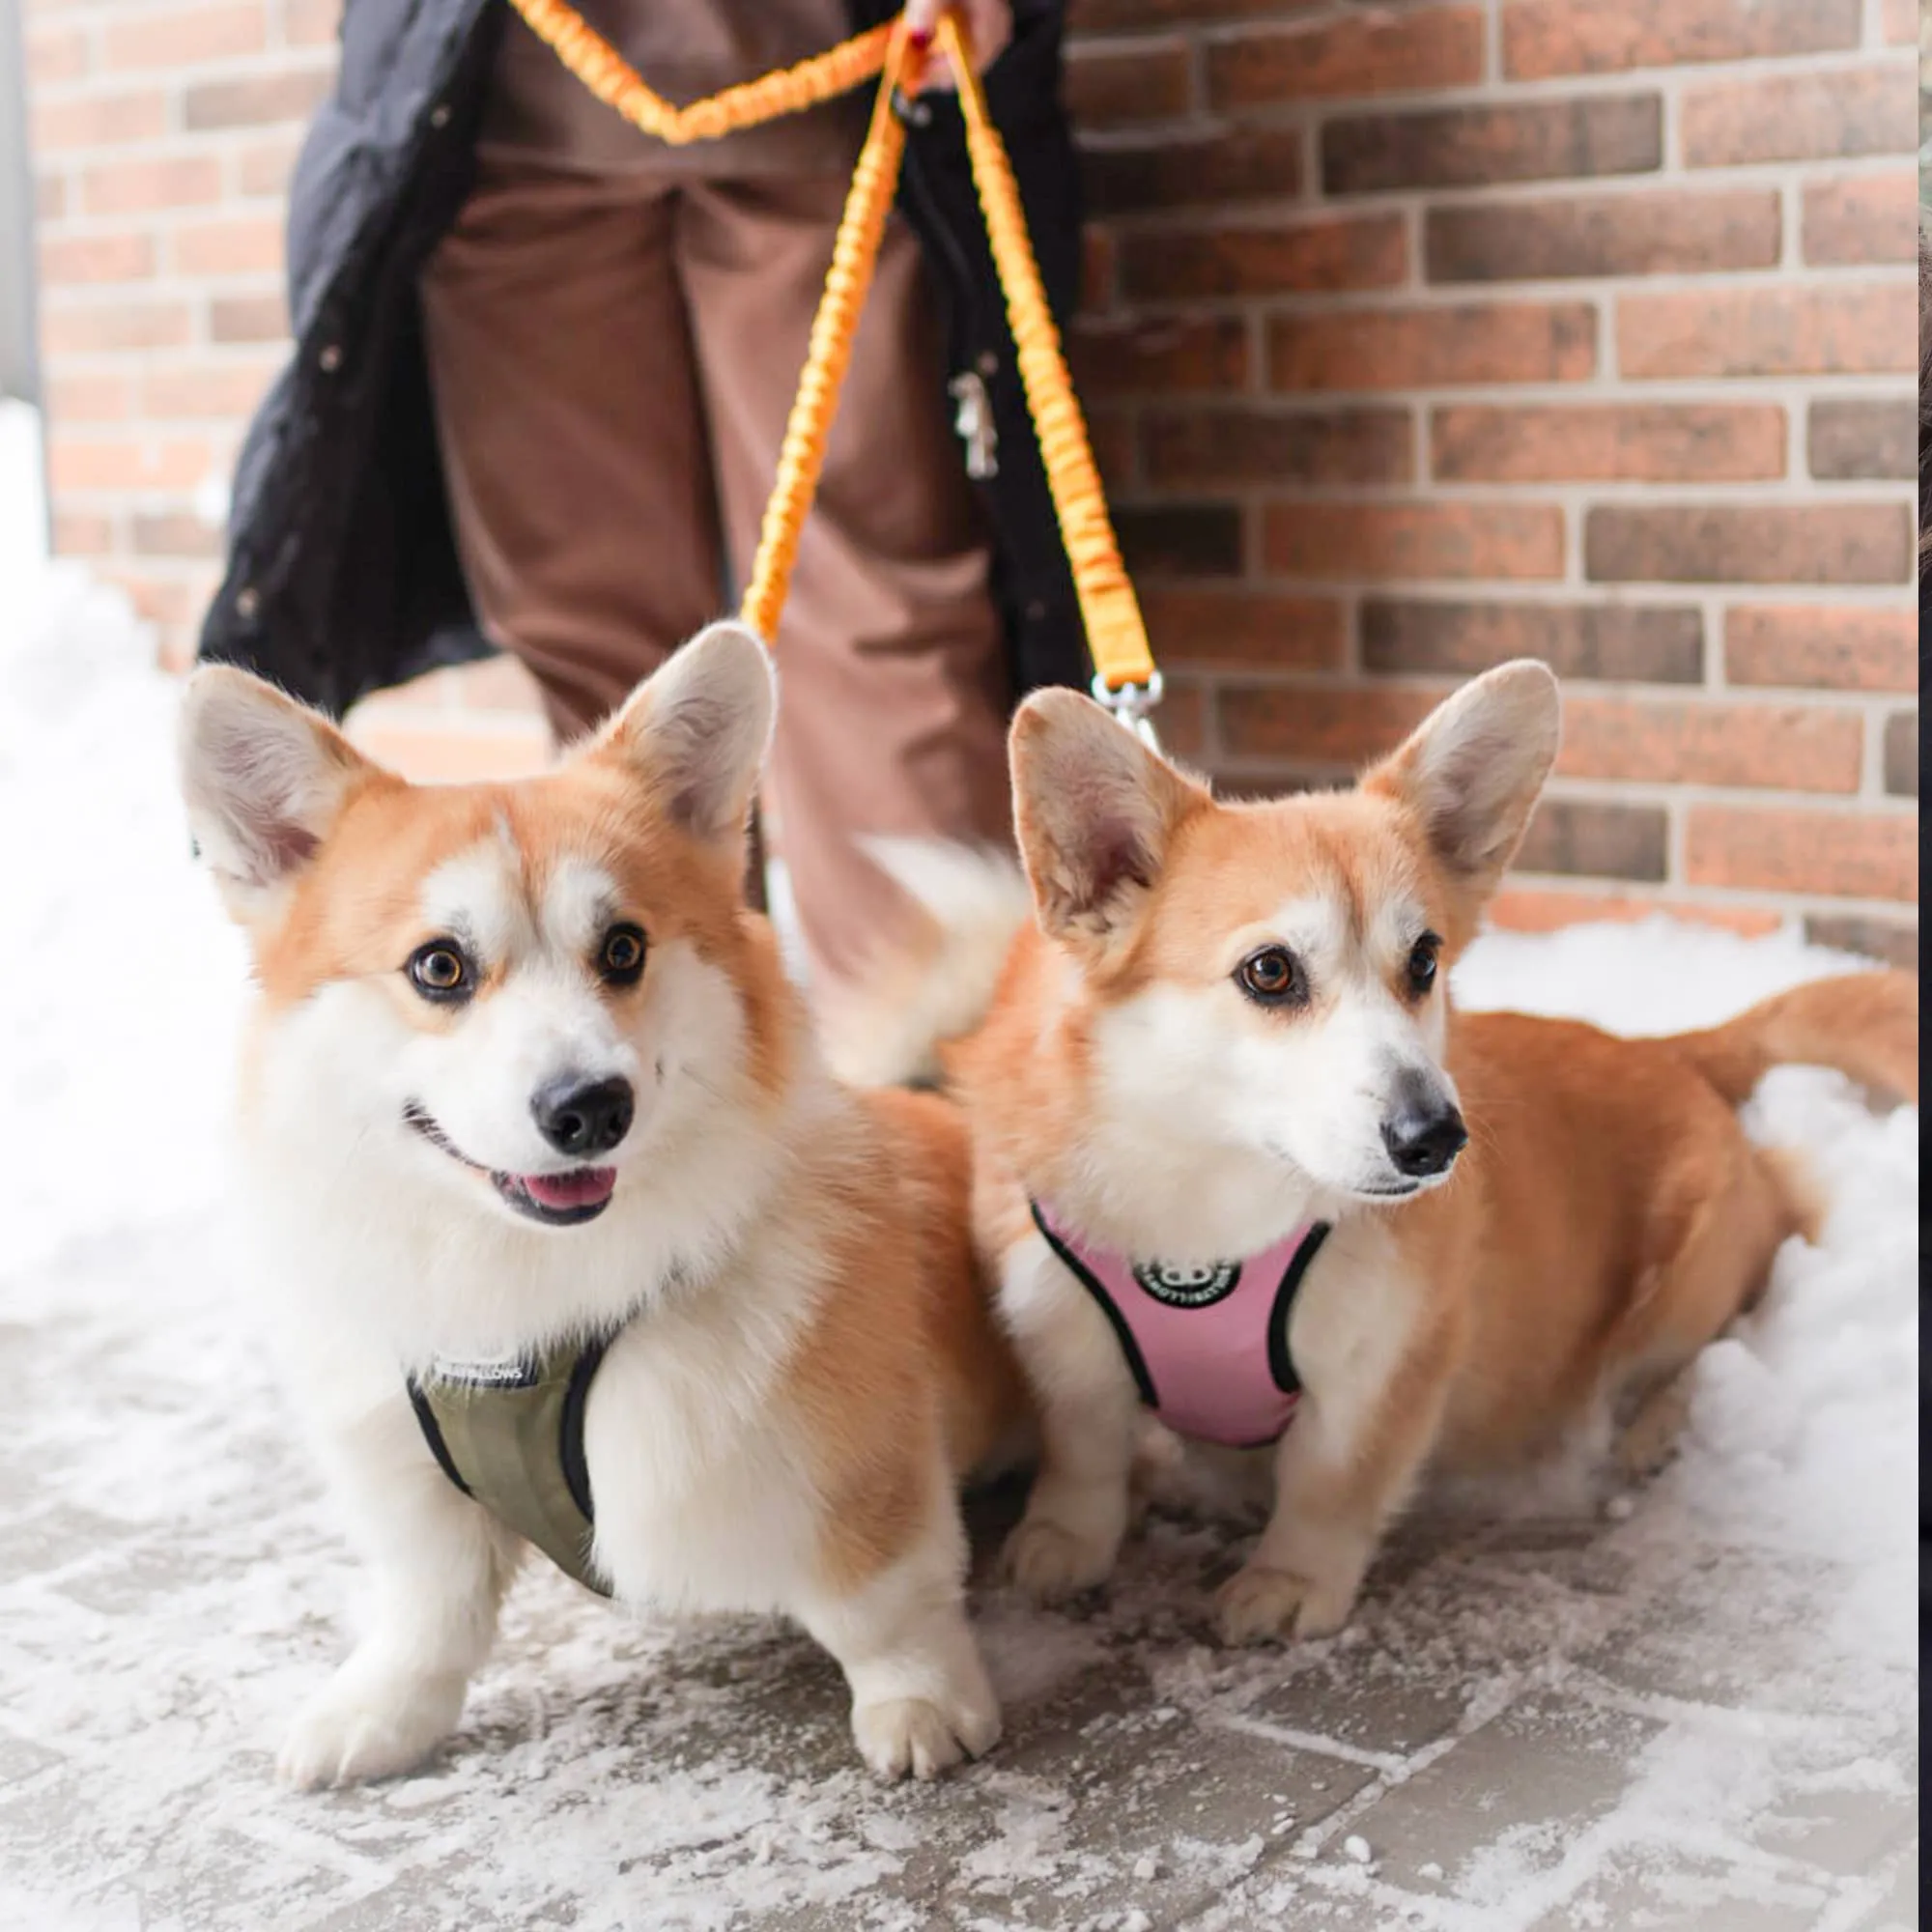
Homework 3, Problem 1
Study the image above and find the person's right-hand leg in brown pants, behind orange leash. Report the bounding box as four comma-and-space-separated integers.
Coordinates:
678, 176, 1010, 991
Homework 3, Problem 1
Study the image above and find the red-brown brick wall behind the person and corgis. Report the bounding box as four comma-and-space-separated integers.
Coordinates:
27, 0, 1917, 956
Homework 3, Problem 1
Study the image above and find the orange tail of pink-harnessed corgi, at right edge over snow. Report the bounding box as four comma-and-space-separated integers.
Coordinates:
1673, 972, 1918, 1105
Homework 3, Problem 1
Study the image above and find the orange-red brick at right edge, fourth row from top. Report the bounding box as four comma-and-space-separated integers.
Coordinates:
1617, 280, 1918, 379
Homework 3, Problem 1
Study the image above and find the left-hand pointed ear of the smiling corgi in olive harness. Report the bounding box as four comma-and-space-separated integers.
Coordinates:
178, 665, 381, 920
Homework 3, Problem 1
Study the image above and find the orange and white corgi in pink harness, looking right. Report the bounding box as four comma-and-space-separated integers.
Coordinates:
848, 661, 1918, 1642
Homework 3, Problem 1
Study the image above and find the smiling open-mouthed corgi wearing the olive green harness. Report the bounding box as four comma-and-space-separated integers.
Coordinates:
180, 624, 1028, 1787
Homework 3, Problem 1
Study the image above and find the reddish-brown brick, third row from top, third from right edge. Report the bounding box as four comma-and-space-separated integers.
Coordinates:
1121, 214, 1408, 301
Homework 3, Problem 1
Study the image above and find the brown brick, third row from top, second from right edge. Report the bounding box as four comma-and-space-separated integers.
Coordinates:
1424, 187, 1783, 282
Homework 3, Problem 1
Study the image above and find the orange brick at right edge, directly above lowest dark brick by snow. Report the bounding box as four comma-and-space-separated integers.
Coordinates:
1685, 806, 1918, 904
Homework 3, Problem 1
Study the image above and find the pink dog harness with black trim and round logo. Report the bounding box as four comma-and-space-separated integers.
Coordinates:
1032, 1202, 1329, 1449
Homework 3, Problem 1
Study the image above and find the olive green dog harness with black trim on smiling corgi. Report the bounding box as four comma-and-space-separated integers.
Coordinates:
410, 1329, 616, 1596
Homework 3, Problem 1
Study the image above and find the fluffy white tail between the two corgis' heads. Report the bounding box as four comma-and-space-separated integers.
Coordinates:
821, 838, 1034, 1086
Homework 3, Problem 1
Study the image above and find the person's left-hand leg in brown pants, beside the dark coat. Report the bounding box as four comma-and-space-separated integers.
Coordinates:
423, 162, 719, 738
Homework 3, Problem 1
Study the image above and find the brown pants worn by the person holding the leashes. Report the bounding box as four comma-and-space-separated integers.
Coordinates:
423, 158, 1010, 983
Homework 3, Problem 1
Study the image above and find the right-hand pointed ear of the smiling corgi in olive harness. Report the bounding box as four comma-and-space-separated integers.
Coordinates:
607, 622, 781, 844
